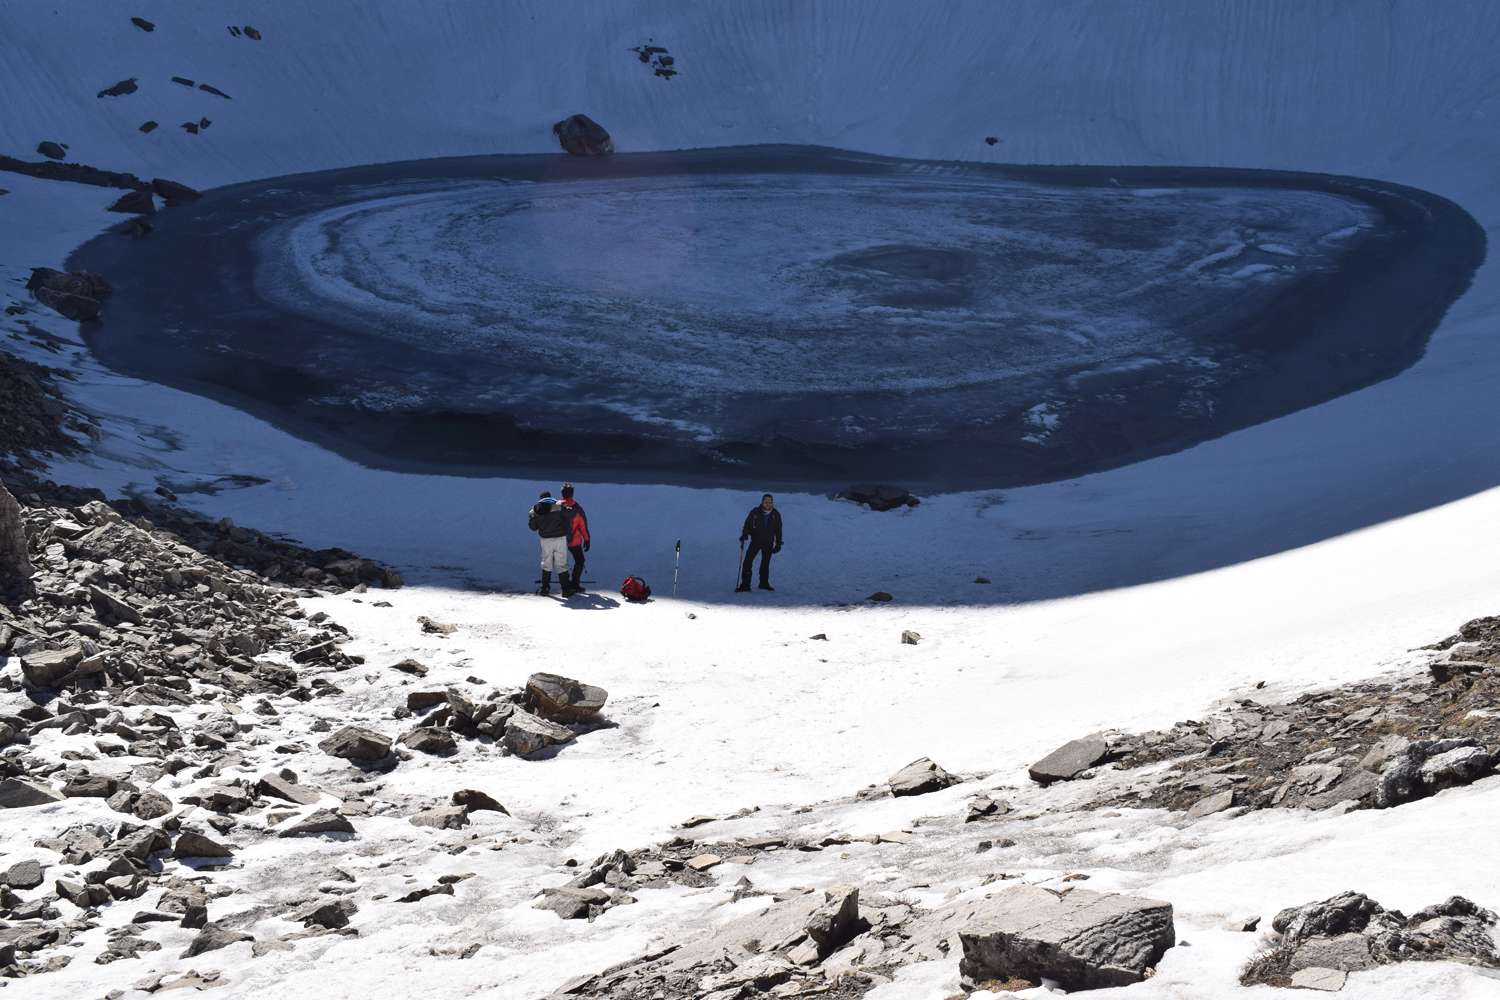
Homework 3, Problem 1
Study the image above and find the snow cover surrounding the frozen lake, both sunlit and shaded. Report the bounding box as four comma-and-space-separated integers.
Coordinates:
0, 0, 1500, 1000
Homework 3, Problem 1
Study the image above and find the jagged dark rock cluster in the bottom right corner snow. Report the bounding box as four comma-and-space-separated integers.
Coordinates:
1241, 892, 1500, 988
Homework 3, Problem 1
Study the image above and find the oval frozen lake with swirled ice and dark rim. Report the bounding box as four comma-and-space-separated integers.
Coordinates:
77, 147, 1484, 487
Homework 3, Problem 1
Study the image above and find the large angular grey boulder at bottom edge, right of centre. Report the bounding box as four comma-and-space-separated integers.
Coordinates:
959, 886, 1178, 993
